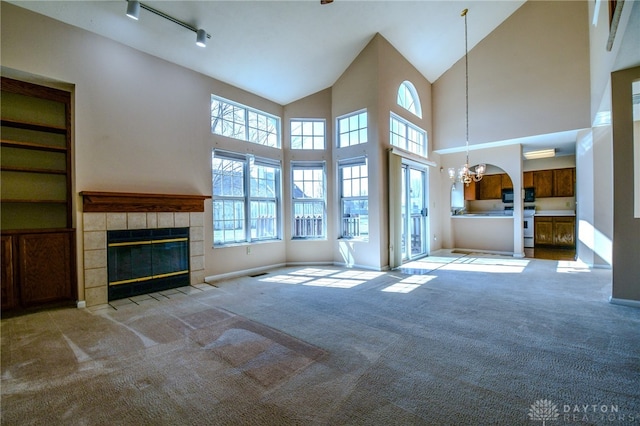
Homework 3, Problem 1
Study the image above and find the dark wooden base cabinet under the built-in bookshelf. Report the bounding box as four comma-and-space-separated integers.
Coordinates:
2, 229, 76, 310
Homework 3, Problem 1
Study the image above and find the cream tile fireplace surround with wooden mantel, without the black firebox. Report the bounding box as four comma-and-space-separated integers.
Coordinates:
81, 192, 209, 307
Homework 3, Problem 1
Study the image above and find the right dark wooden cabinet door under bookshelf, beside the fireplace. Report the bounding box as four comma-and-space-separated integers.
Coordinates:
18, 232, 75, 307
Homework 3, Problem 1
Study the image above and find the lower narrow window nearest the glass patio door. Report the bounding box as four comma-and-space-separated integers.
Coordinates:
339, 157, 369, 239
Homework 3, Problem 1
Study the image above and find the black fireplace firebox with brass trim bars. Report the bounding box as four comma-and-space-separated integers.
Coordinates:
107, 228, 189, 300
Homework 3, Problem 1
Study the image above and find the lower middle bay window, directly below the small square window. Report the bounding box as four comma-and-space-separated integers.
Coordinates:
291, 161, 326, 239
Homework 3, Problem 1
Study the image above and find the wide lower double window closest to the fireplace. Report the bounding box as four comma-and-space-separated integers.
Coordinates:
211, 150, 280, 245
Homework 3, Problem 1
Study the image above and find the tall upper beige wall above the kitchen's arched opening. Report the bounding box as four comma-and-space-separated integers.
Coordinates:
433, 1, 590, 150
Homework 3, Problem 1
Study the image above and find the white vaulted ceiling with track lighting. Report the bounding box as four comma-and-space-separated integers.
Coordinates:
10, 0, 524, 105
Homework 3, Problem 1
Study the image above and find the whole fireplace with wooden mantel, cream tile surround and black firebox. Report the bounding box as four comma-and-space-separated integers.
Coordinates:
78, 191, 211, 307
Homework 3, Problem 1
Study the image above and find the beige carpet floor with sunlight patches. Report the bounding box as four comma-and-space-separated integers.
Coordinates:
1, 252, 640, 425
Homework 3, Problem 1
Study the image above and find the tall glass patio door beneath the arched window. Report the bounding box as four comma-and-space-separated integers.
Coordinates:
401, 164, 429, 261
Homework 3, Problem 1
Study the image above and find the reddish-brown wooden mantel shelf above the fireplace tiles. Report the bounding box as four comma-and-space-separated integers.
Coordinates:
80, 191, 211, 213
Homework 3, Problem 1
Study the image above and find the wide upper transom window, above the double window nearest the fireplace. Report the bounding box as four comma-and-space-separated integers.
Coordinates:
211, 95, 280, 148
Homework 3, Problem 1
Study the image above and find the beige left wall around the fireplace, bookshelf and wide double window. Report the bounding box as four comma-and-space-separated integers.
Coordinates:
1, 3, 288, 297
